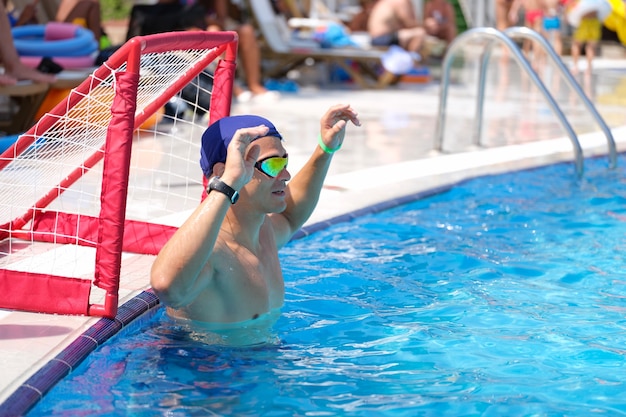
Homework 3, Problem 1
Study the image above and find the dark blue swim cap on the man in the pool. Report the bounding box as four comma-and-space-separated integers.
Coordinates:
200, 115, 283, 177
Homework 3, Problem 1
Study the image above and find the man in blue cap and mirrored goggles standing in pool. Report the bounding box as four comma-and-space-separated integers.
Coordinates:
151, 104, 361, 327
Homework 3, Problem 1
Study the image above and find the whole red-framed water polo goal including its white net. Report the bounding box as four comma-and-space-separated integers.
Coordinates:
0, 31, 238, 318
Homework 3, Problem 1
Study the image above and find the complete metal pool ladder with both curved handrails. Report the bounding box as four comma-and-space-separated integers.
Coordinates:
435, 26, 617, 177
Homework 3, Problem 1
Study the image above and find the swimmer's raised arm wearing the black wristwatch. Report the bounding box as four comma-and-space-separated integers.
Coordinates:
150, 126, 268, 308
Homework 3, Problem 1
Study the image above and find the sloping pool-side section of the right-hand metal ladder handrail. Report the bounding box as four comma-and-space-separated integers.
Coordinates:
502, 26, 617, 168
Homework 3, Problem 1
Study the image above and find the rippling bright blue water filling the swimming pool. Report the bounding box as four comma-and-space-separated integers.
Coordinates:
29, 158, 626, 417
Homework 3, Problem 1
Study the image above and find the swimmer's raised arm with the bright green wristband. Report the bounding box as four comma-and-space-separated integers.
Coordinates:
271, 104, 361, 248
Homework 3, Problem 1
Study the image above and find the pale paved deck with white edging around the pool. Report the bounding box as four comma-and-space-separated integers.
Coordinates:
0, 47, 626, 412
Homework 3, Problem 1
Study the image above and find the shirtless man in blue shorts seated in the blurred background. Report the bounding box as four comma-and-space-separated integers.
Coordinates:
367, 0, 427, 55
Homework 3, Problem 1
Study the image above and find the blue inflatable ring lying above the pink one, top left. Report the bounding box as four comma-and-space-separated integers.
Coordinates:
11, 23, 98, 57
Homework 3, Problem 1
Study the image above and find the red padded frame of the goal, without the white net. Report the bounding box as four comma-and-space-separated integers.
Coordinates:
0, 31, 238, 318
